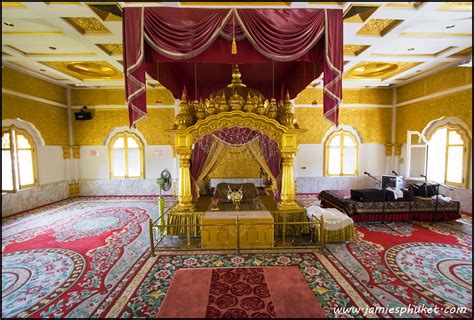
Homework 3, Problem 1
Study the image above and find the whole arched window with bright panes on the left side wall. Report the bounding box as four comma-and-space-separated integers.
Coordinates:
2, 126, 38, 192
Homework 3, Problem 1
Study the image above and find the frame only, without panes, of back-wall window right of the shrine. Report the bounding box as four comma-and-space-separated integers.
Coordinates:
324, 129, 359, 177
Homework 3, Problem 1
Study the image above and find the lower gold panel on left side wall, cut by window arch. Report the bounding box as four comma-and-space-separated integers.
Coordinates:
2, 93, 69, 145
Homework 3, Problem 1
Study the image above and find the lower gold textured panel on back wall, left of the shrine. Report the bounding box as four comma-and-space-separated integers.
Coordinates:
73, 108, 174, 145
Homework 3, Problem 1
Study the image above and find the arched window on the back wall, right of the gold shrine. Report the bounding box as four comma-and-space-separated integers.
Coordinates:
324, 130, 358, 176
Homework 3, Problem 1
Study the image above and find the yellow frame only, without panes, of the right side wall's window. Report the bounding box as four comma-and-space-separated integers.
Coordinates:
427, 123, 471, 188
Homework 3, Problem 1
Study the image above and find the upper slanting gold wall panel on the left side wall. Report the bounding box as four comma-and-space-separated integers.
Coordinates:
2, 68, 67, 104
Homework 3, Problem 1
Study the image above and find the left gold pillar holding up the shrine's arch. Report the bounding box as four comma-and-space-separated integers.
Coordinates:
175, 133, 194, 212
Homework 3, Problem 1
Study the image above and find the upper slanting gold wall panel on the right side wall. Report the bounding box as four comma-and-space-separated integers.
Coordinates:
397, 67, 472, 103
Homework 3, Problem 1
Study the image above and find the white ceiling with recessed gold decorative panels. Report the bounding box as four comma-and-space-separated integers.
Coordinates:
2, 2, 472, 87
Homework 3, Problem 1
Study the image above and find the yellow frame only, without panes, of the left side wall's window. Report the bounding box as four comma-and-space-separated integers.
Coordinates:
2, 125, 39, 193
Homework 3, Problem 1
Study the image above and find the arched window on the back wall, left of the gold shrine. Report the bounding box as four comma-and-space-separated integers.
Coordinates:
109, 132, 144, 179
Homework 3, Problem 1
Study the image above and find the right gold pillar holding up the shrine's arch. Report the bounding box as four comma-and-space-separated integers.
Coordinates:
278, 134, 301, 210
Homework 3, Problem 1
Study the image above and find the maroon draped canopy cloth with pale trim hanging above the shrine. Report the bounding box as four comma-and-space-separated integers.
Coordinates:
123, 7, 343, 126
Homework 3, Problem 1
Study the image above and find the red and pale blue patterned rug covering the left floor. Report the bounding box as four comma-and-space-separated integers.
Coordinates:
2, 197, 174, 318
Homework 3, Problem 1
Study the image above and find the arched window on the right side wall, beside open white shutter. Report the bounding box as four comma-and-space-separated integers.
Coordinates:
427, 124, 470, 187
